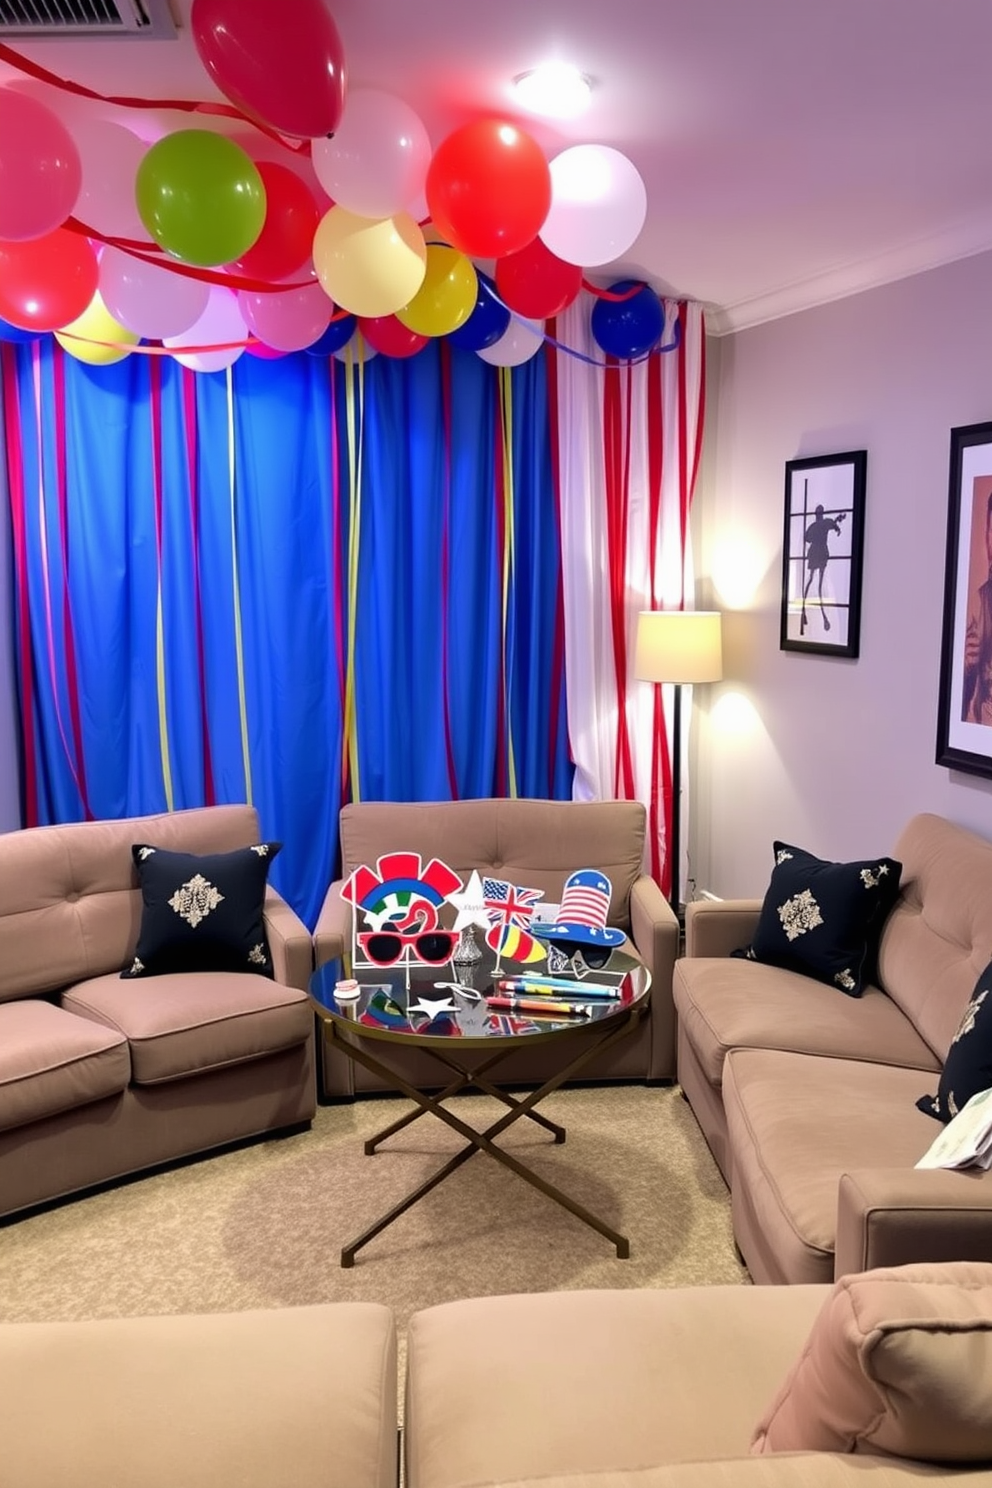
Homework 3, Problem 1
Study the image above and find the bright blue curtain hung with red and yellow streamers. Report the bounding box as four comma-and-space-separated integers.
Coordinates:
3, 338, 573, 926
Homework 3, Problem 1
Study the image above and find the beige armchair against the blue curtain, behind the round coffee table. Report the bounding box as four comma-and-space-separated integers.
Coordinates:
314, 799, 678, 1097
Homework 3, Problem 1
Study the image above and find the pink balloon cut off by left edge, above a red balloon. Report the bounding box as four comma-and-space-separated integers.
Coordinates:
0, 88, 83, 243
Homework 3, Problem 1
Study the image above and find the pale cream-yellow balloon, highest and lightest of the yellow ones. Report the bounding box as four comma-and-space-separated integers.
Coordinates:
314, 207, 427, 317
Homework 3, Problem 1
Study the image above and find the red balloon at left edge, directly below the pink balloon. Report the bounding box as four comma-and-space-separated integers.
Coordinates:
0, 228, 100, 330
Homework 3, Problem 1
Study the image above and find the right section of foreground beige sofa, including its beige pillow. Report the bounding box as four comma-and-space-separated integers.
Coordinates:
403, 1265, 992, 1488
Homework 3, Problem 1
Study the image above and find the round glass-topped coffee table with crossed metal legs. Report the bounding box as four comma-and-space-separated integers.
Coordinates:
309, 951, 651, 1266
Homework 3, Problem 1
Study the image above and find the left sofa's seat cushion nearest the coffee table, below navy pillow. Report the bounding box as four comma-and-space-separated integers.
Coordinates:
62, 972, 314, 1085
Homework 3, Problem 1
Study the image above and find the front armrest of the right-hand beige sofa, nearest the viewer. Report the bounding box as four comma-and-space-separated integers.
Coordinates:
834, 1168, 992, 1277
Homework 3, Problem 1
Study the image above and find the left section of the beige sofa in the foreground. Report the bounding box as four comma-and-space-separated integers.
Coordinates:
0, 1302, 399, 1488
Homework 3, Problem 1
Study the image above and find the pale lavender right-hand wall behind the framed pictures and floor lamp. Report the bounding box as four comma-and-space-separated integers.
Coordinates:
689, 254, 992, 897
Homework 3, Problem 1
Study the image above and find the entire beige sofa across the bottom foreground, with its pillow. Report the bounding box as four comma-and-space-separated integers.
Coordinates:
0, 1265, 992, 1488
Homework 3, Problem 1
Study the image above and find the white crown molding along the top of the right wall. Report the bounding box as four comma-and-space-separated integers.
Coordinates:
705, 214, 992, 336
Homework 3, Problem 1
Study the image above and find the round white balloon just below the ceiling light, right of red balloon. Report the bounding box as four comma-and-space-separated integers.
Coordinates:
538, 144, 647, 268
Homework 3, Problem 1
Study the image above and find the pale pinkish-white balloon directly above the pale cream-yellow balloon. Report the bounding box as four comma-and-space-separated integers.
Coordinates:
311, 88, 431, 217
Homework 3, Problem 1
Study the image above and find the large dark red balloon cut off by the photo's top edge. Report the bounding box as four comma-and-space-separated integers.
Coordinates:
190, 0, 345, 140
